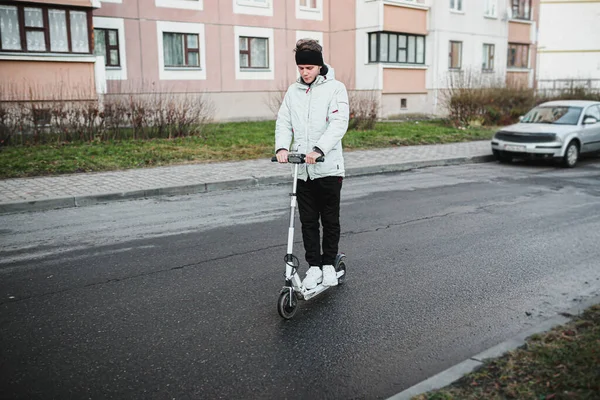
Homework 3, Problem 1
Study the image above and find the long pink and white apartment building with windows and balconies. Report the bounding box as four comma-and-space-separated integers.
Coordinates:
0, 0, 540, 120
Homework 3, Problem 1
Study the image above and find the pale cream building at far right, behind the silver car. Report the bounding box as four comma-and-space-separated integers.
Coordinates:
538, 0, 600, 90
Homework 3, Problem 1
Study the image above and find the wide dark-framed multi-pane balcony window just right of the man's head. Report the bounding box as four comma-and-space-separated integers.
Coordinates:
369, 32, 425, 64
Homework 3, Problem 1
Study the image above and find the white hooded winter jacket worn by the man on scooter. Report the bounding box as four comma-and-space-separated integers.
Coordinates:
275, 66, 349, 181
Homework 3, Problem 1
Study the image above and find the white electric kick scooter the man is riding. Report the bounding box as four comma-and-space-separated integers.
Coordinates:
271, 153, 346, 319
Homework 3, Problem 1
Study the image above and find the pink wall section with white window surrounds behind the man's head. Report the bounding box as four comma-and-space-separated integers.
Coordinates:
94, 0, 338, 118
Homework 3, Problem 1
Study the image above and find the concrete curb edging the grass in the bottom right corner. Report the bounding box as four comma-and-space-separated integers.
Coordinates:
387, 295, 600, 400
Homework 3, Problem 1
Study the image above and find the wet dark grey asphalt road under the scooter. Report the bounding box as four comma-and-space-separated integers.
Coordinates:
0, 159, 600, 399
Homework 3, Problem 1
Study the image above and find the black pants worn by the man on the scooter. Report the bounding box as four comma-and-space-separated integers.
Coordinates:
297, 176, 343, 267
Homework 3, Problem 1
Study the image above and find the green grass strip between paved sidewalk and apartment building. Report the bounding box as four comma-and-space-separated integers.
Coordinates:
0, 121, 494, 178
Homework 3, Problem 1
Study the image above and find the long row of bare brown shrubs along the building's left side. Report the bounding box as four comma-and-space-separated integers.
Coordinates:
0, 78, 214, 145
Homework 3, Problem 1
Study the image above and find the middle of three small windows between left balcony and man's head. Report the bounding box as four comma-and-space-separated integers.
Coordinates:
163, 32, 200, 68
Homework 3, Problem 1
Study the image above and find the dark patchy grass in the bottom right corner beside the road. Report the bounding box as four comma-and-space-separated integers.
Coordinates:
413, 306, 600, 400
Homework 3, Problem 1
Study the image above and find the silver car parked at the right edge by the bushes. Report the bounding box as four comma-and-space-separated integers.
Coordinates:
492, 100, 600, 168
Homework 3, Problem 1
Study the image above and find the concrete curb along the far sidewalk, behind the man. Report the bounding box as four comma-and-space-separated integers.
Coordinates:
0, 155, 494, 215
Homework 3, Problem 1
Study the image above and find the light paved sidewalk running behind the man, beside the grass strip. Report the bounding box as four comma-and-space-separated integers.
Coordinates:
0, 140, 492, 214
